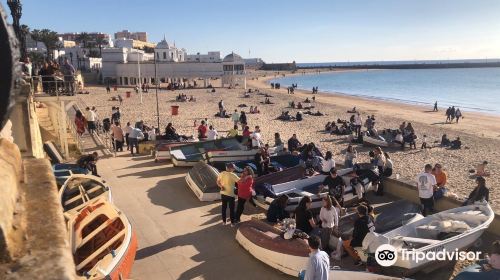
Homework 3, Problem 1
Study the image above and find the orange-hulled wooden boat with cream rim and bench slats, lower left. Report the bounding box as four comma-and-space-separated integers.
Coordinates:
68, 198, 137, 280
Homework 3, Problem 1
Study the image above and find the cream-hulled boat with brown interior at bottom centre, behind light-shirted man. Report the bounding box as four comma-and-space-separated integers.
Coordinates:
236, 220, 410, 280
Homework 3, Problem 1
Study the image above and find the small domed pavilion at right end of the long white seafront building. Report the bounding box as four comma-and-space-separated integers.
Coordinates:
222, 52, 247, 89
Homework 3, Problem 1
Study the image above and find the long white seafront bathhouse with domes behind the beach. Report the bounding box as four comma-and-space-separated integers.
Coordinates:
101, 36, 246, 88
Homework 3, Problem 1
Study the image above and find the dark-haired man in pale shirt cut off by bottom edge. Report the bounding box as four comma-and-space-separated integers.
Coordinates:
299, 235, 330, 280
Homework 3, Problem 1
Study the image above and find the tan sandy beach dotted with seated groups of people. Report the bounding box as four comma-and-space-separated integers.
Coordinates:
80, 71, 500, 210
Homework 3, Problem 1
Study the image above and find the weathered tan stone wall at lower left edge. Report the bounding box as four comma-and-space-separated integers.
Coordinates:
0, 139, 76, 280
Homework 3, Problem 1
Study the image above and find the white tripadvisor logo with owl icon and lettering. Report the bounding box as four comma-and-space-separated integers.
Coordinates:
375, 244, 481, 267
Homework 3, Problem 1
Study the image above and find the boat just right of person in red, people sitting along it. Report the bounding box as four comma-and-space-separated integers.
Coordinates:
254, 168, 374, 212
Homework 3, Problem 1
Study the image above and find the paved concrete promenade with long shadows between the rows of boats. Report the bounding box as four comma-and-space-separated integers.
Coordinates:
84, 136, 290, 280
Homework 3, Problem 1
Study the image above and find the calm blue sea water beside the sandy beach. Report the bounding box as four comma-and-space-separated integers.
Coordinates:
270, 68, 500, 115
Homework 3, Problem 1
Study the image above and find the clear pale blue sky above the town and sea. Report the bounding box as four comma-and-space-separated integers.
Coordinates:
0, 0, 500, 62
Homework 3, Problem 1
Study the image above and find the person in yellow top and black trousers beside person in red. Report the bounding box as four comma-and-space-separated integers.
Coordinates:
217, 163, 240, 226
